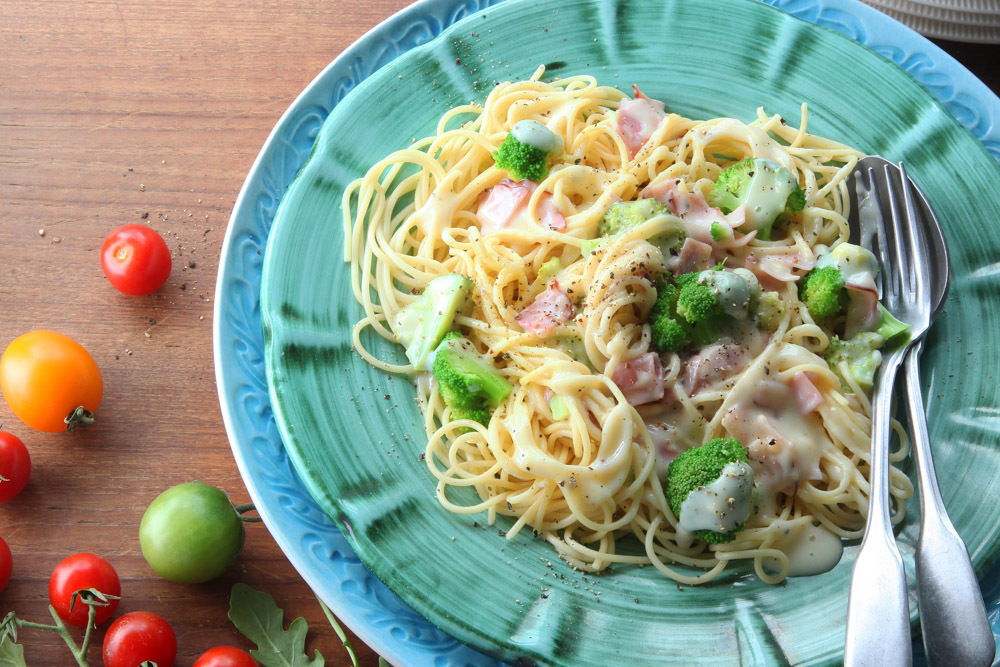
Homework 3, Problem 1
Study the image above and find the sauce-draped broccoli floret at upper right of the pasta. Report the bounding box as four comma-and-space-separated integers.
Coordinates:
708, 158, 806, 240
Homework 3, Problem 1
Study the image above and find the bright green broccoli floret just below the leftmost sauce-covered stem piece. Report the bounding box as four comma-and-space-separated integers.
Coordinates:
433, 332, 513, 426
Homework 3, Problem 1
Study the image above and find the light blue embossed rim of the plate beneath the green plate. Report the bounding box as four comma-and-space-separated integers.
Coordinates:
213, 0, 1000, 662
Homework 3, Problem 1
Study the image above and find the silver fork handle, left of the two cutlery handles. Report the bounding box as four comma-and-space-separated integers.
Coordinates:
844, 349, 912, 667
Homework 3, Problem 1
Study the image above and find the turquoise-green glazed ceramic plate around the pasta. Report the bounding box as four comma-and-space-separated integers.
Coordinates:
252, 0, 1000, 664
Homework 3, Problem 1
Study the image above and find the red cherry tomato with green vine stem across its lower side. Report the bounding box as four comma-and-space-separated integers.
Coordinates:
49, 553, 122, 628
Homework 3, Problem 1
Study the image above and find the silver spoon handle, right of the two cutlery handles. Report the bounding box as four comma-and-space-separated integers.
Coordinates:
904, 342, 996, 667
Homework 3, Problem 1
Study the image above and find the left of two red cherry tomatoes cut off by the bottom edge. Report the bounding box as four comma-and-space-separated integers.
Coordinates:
104, 611, 177, 667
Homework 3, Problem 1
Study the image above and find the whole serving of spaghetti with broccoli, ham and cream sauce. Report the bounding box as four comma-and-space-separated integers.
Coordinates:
343, 68, 912, 584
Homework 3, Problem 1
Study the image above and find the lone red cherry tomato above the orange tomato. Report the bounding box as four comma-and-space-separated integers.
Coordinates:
101, 225, 171, 296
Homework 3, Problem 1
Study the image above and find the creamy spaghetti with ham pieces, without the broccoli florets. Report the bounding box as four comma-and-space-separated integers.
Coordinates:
342, 68, 912, 584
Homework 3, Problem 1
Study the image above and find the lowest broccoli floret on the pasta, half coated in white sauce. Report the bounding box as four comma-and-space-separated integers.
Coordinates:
666, 438, 753, 544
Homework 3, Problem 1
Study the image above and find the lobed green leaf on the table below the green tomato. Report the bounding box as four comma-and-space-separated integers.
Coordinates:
229, 583, 325, 667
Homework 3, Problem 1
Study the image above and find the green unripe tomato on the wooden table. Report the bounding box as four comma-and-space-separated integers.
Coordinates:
139, 482, 245, 584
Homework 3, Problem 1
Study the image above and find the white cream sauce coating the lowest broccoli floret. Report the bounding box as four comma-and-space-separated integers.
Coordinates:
677, 461, 753, 533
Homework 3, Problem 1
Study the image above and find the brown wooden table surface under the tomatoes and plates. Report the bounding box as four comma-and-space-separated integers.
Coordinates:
0, 0, 1000, 665
